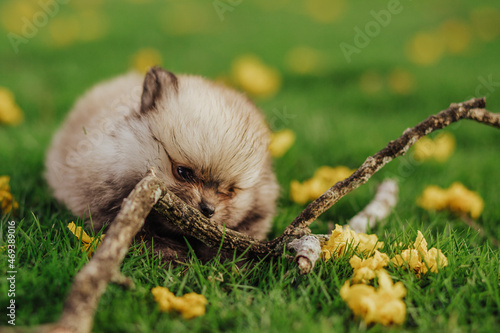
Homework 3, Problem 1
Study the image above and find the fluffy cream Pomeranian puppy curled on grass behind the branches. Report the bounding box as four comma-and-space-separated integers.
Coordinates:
46, 67, 279, 261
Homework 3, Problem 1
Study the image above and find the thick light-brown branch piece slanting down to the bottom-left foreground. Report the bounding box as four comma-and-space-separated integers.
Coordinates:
43, 171, 165, 332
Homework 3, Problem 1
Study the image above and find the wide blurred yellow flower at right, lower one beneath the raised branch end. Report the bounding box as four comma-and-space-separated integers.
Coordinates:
417, 182, 484, 219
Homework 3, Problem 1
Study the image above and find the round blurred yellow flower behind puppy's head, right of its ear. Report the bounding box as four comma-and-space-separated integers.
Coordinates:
231, 55, 281, 97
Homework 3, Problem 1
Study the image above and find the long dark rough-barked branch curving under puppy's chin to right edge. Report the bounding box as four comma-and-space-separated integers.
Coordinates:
155, 98, 500, 257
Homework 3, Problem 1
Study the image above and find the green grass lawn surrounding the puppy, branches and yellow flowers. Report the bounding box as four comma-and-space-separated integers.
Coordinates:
0, 0, 500, 332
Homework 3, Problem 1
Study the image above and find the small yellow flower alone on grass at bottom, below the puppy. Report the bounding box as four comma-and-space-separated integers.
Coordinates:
151, 287, 207, 319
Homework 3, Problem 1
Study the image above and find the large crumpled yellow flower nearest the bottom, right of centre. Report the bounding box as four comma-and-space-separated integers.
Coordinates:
340, 270, 406, 325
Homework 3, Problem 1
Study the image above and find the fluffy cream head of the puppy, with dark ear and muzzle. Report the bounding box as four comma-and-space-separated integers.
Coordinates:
140, 68, 270, 227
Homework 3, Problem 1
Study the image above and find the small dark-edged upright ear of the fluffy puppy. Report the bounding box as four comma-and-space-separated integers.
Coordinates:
141, 67, 179, 114
